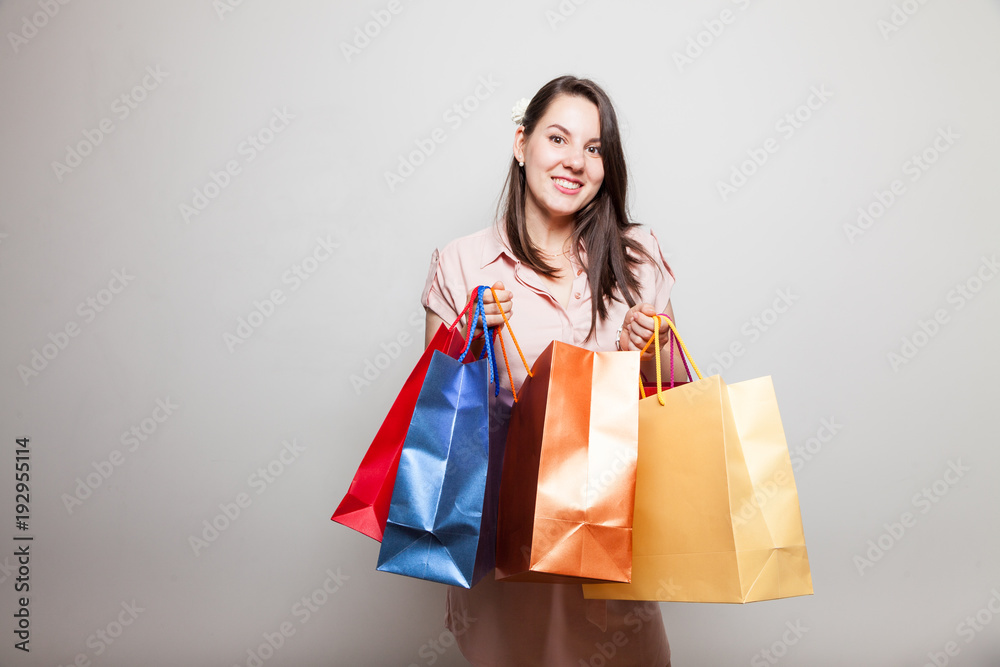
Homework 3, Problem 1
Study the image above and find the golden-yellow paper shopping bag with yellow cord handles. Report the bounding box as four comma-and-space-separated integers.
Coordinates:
583, 317, 813, 603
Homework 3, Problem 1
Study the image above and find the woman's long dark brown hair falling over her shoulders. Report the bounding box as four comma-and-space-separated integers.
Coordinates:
497, 76, 655, 340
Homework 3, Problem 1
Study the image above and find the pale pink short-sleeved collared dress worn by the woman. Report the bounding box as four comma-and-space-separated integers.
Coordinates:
420, 222, 674, 667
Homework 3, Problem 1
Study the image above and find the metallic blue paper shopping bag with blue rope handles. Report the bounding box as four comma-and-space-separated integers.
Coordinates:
377, 287, 513, 588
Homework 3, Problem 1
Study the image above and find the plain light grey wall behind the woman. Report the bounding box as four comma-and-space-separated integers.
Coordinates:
0, 0, 1000, 667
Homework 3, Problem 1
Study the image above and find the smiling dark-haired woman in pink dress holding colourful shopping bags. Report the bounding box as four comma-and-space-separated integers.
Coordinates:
421, 76, 687, 667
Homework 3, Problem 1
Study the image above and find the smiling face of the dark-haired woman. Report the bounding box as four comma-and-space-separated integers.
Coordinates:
514, 95, 604, 224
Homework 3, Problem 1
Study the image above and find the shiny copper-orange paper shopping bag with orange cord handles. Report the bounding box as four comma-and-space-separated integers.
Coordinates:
496, 341, 639, 583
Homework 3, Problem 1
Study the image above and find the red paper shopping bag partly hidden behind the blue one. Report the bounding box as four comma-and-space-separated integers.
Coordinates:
330, 294, 476, 541
